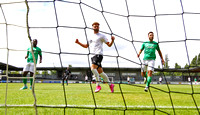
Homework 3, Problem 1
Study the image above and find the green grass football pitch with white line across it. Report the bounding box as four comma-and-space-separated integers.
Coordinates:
0, 83, 200, 115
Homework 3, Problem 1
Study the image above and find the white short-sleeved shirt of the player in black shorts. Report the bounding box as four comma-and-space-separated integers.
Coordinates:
89, 33, 108, 55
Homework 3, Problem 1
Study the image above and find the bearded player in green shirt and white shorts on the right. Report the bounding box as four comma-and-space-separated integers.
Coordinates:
138, 32, 165, 92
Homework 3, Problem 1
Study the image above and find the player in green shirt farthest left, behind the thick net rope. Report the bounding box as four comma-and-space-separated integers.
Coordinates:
20, 39, 42, 90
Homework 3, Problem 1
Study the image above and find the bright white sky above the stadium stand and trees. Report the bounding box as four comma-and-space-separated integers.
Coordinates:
0, 0, 200, 68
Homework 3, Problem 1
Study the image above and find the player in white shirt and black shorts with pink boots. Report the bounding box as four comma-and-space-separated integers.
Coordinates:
75, 22, 115, 93
